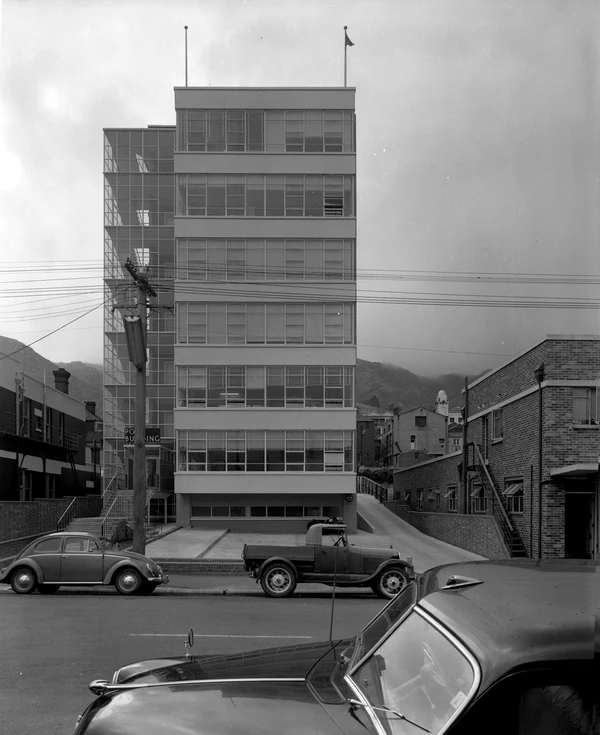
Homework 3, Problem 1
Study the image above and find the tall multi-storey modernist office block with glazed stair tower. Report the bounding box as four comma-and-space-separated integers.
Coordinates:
105, 87, 356, 530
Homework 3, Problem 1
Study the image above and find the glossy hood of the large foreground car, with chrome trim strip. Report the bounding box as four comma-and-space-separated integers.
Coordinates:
76, 641, 368, 735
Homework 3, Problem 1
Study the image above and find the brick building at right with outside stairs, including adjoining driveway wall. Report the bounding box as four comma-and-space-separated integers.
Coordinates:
394, 335, 600, 558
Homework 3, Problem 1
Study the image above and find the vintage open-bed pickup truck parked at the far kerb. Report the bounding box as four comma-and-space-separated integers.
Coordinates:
242, 523, 415, 598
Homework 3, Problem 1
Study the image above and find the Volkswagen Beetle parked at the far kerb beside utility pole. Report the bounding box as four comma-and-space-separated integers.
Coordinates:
0, 531, 169, 595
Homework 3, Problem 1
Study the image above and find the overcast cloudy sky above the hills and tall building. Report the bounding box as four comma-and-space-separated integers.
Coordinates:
0, 0, 600, 375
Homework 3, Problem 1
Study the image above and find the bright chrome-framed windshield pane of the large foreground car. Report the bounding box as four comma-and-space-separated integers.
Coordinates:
352, 611, 475, 735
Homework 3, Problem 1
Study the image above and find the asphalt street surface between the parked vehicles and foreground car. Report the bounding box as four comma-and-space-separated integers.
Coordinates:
0, 592, 385, 735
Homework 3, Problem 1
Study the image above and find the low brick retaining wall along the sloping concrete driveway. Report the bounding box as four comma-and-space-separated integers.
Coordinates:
385, 501, 510, 559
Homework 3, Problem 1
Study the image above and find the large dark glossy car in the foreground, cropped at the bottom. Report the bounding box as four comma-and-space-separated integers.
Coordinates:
75, 560, 600, 735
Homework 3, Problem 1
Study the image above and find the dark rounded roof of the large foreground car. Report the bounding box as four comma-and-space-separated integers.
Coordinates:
419, 560, 600, 680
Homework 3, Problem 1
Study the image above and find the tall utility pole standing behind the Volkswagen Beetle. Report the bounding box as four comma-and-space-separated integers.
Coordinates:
125, 258, 156, 554
